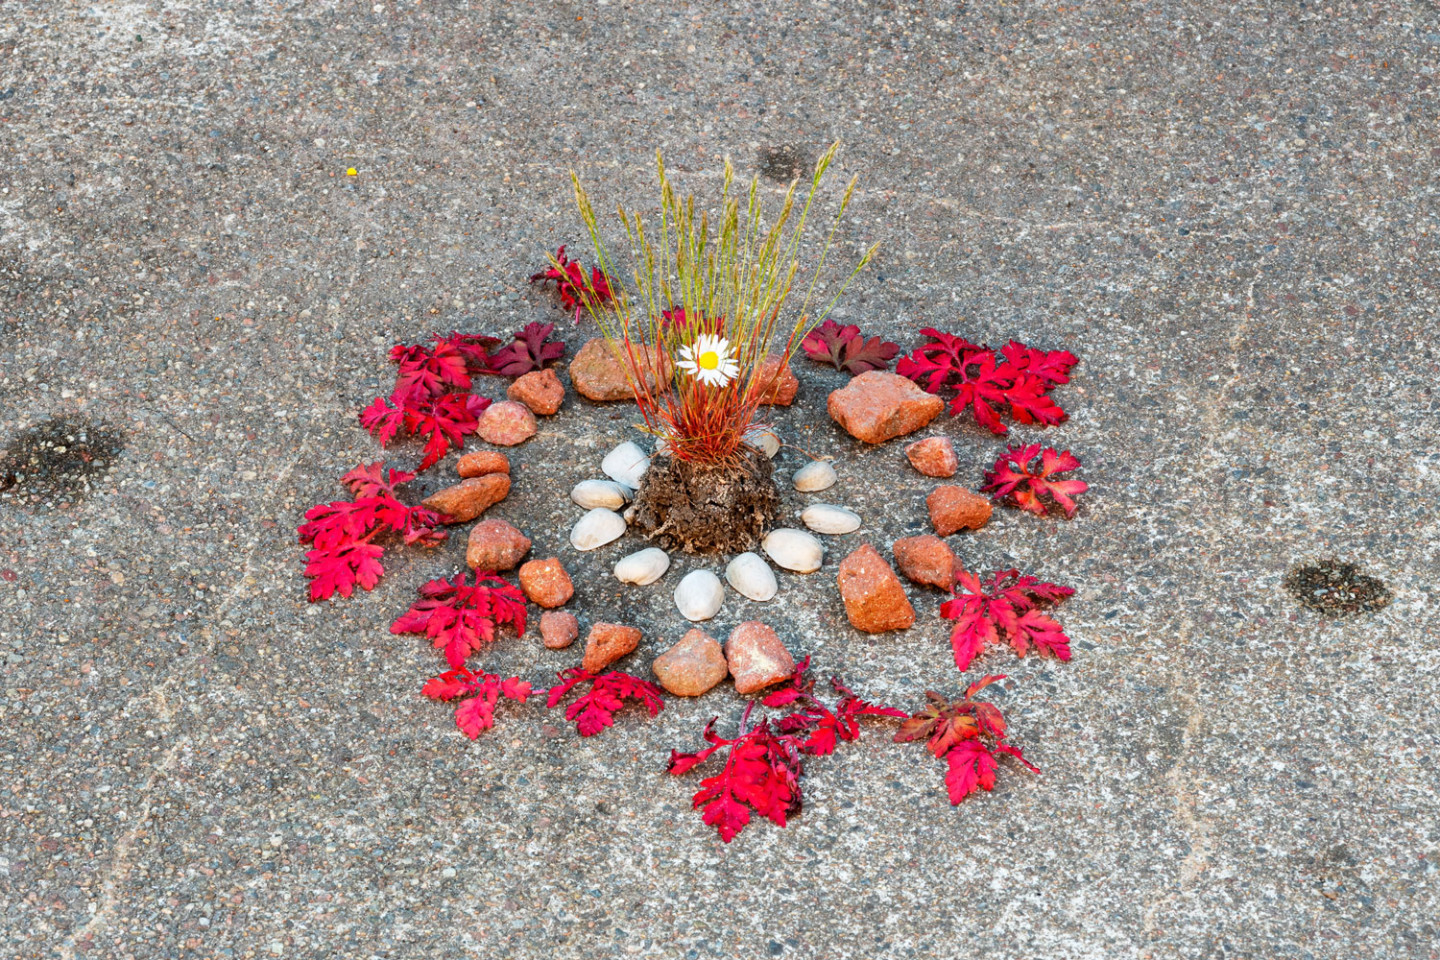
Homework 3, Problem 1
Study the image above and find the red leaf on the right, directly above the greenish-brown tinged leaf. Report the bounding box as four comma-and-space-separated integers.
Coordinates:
940, 570, 1074, 671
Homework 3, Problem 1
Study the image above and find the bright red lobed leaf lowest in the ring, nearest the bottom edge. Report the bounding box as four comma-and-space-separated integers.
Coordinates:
667, 701, 805, 843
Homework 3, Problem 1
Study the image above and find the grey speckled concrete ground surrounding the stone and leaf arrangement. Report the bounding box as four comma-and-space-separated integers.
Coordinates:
0, 0, 1440, 960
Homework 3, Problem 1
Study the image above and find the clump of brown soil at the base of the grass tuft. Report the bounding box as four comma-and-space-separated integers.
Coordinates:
635, 446, 780, 553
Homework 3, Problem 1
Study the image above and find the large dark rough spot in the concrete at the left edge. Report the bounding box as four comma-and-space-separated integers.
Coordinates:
0, 417, 125, 504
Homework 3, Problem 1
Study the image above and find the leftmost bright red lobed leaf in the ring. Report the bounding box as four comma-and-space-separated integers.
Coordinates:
297, 462, 445, 603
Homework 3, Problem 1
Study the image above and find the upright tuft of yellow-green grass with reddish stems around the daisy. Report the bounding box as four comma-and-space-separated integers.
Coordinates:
570, 141, 878, 463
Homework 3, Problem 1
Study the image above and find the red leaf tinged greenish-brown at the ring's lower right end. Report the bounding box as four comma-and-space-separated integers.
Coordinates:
894, 675, 1040, 805
